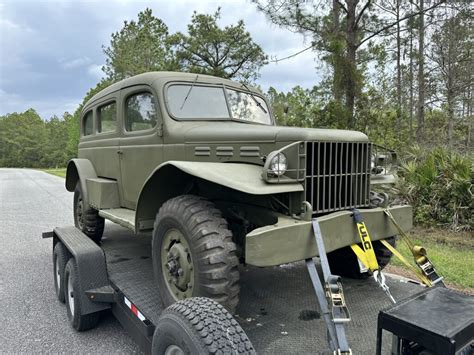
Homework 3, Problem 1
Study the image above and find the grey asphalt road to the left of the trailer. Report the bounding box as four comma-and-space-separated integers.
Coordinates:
0, 169, 140, 354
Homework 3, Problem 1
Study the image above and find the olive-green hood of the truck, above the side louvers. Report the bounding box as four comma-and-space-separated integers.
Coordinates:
184, 122, 368, 143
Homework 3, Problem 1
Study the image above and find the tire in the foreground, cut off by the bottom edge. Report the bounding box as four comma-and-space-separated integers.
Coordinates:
152, 297, 255, 355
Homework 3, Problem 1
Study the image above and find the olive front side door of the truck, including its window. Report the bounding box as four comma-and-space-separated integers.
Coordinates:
119, 85, 163, 210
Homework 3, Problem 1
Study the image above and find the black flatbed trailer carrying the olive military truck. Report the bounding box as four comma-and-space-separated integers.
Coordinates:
43, 225, 470, 354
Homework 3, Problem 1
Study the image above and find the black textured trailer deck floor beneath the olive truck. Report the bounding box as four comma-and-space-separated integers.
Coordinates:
102, 224, 423, 354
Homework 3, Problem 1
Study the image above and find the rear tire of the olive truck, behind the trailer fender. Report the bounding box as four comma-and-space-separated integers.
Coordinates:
73, 181, 104, 244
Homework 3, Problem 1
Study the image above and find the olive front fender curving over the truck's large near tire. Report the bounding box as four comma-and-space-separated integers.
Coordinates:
135, 161, 303, 232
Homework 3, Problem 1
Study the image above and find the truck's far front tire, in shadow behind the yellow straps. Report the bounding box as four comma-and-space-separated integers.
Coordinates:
328, 237, 395, 279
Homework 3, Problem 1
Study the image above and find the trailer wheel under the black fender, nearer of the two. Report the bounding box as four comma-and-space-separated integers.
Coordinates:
64, 258, 99, 331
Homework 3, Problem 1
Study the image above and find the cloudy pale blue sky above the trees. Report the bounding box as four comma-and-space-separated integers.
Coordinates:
0, 0, 320, 119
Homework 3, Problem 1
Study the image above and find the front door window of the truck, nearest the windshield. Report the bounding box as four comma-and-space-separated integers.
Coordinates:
125, 92, 157, 132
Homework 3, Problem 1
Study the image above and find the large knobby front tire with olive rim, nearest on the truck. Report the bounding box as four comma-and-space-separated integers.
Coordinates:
152, 195, 240, 312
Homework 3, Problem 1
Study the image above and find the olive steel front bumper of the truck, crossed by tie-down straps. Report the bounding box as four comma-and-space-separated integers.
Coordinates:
245, 206, 413, 266
